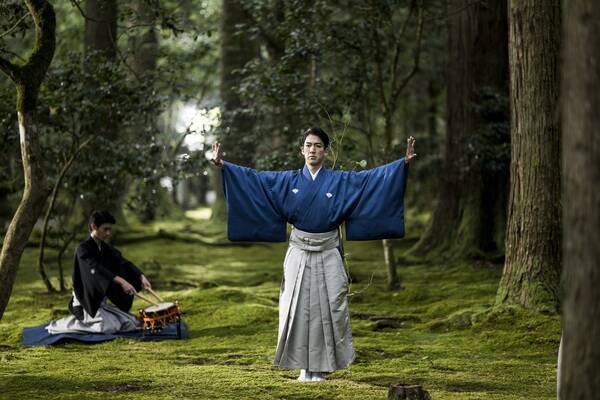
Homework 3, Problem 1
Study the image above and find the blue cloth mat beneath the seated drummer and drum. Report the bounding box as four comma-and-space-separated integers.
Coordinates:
22, 321, 189, 346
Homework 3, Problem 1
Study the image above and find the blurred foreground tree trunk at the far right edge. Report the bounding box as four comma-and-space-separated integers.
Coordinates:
560, 0, 600, 400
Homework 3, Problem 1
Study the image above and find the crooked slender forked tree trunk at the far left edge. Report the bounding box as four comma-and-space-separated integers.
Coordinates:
0, 0, 56, 319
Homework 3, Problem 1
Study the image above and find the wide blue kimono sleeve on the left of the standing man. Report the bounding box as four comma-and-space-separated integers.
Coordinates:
223, 162, 287, 242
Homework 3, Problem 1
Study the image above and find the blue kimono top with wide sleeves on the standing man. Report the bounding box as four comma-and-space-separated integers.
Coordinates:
223, 158, 408, 242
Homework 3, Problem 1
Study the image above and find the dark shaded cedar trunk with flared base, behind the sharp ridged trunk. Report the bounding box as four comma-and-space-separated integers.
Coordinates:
411, 0, 509, 257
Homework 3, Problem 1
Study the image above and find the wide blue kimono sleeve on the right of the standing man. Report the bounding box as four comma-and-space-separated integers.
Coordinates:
345, 158, 408, 240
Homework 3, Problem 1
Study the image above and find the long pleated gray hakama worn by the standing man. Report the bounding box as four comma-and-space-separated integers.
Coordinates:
275, 228, 355, 372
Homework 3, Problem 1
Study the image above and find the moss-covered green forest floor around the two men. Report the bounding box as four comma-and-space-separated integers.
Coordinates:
0, 211, 560, 400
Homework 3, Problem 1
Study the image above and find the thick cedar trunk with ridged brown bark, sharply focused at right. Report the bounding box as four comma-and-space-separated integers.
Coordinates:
496, 0, 561, 309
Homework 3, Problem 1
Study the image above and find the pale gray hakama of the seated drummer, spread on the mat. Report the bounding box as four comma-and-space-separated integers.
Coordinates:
46, 293, 141, 335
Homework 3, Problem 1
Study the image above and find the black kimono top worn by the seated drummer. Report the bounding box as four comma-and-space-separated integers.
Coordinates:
69, 237, 142, 320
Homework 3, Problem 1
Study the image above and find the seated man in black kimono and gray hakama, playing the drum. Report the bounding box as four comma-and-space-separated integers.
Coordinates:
46, 211, 151, 334
